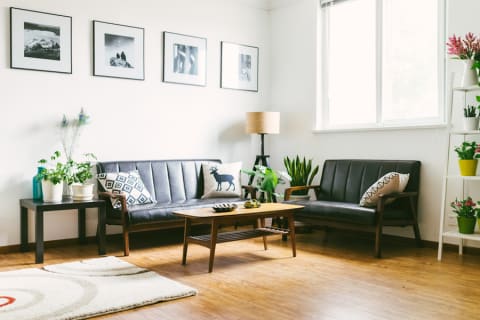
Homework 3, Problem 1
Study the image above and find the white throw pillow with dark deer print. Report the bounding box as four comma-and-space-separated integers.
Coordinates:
202, 162, 242, 199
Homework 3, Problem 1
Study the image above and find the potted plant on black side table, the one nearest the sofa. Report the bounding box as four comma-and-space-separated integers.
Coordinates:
67, 153, 97, 200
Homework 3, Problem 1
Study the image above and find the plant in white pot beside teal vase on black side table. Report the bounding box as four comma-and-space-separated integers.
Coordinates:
37, 151, 67, 202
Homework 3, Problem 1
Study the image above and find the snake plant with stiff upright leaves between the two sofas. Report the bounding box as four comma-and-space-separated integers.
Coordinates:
283, 155, 319, 199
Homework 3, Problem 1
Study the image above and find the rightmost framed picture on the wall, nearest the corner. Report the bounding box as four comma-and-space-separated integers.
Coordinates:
220, 41, 258, 91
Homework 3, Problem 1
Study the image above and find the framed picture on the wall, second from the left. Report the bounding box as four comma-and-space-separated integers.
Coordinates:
93, 20, 145, 80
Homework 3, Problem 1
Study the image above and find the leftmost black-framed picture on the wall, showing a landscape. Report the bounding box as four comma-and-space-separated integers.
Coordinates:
10, 7, 72, 73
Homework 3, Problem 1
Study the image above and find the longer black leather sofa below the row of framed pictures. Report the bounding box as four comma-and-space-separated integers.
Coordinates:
96, 159, 251, 256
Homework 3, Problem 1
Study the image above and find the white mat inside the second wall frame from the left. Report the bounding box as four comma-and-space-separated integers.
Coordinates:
93, 21, 144, 80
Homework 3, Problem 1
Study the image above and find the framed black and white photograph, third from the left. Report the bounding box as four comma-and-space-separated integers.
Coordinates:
163, 31, 207, 86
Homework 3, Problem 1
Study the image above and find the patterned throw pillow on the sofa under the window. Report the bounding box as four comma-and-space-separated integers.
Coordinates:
360, 172, 410, 207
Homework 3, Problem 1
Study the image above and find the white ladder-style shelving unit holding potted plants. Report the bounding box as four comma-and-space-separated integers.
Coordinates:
438, 86, 480, 261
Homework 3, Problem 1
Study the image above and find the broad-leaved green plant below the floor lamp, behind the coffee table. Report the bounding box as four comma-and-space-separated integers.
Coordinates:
242, 165, 291, 202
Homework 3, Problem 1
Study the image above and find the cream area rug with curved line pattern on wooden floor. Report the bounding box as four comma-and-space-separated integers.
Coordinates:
0, 257, 197, 320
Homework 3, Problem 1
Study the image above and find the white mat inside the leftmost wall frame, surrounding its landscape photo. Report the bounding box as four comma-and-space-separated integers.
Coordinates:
11, 8, 72, 73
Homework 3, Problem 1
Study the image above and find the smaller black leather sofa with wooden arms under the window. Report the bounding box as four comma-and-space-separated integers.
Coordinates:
284, 159, 422, 257
